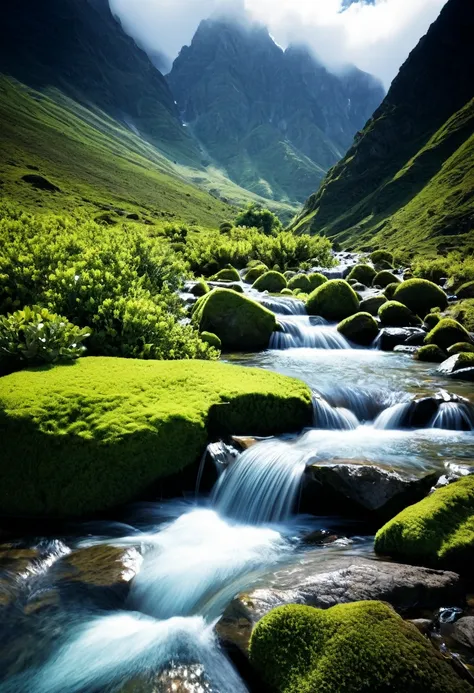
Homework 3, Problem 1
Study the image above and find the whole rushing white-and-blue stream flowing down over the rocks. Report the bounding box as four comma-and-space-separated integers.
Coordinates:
0, 264, 474, 693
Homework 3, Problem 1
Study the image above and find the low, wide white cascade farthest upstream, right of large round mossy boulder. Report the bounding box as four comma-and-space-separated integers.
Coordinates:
269, 316, 351, 349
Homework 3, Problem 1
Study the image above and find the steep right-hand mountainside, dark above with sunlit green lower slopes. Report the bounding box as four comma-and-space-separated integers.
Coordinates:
292, 0, 474, 252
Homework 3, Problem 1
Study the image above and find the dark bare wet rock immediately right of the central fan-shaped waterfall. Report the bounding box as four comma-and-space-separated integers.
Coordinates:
301, 461, 438, 519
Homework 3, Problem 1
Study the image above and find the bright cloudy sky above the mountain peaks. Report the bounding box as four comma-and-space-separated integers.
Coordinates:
110, 0, 446, 89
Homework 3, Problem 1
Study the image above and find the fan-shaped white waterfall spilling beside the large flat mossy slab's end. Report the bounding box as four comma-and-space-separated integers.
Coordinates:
213, 440, 305, 524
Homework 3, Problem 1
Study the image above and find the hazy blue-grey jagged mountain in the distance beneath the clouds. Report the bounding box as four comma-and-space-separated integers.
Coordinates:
168, 19, 384, 201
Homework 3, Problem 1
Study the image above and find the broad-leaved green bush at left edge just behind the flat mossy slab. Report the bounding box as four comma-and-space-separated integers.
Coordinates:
0, 306, 91, 373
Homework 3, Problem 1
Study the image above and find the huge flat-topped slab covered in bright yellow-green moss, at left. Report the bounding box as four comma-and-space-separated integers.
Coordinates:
0, 360, 312, 518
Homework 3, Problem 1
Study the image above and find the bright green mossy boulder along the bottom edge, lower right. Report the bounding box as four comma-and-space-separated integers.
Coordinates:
250, 601, 472, 693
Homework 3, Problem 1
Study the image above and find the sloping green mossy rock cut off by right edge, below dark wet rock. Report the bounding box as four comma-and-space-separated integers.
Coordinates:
375, 476, 474, 573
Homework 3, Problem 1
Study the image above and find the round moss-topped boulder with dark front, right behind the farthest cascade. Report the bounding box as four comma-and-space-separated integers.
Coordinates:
306, 279, 359, 322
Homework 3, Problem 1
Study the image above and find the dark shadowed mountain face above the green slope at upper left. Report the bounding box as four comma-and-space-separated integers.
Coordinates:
0, 0, 197, 160
